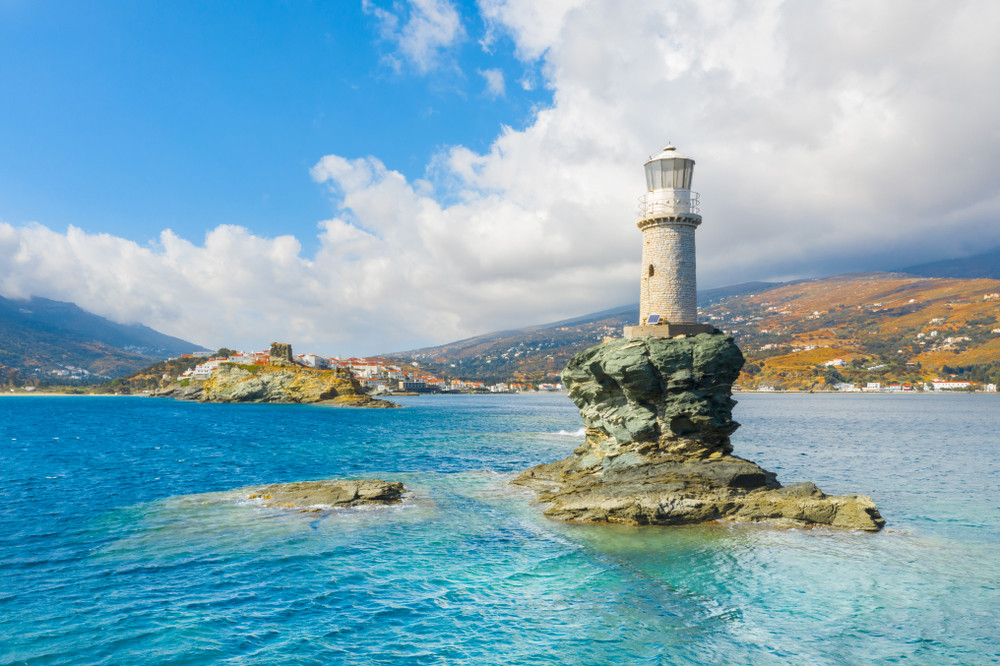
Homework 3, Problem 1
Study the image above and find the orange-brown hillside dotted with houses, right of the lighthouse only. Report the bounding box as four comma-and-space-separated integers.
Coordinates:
702, 273, 1000, 390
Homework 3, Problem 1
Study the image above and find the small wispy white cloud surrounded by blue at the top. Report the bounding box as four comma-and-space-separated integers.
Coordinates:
362, 0, 465, 73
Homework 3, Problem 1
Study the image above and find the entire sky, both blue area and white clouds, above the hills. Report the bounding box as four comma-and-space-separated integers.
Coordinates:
0, 0, 1000, 356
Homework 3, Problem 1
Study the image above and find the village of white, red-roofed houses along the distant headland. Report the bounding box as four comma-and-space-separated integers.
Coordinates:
176, 351, 563, 395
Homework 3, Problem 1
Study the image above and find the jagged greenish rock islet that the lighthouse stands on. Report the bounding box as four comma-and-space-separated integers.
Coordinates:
514, 333, 885, 531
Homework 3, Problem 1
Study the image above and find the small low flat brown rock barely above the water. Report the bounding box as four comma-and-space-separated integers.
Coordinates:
237, 479, 406, 512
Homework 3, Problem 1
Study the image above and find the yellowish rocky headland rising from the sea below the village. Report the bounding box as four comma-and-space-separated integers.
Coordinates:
154, 363, 397, 407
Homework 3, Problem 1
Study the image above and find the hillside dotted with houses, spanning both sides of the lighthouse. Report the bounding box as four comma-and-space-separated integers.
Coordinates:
393, 273, 1000, 390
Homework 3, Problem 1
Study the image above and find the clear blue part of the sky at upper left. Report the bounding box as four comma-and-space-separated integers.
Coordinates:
0, 0, 551, 249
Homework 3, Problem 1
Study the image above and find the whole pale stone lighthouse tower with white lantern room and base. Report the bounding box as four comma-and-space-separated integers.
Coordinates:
625, 145, 715, 338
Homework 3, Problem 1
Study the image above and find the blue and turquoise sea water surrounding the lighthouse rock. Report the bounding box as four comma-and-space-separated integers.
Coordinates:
0, 394, 1000, 664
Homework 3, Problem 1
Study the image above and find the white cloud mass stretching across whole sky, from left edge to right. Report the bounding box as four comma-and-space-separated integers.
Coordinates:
0, 0, 1000, 353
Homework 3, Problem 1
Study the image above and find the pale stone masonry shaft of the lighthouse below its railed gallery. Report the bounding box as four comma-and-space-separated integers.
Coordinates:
639, 218, 701, 324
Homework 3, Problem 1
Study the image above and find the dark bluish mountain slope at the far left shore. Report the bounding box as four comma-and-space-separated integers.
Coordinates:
0, 297, 202, 385
